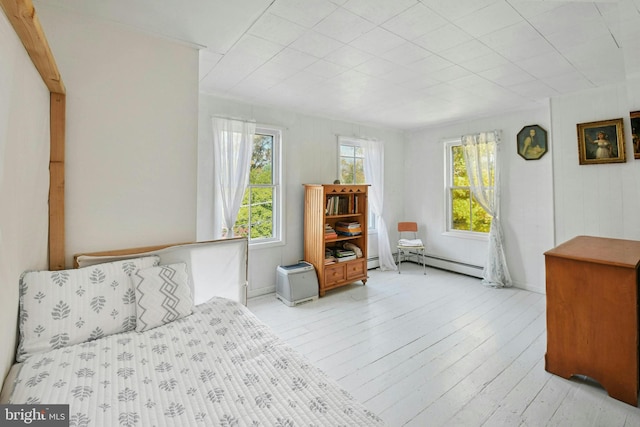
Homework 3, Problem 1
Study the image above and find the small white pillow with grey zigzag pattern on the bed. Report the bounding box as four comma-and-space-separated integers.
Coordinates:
131, 262, 193, 332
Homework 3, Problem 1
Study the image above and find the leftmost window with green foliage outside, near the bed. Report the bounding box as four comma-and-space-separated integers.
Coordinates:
233, 127, 282, 244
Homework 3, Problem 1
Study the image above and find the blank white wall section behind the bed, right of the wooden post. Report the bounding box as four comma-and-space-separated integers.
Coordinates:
38, 2, 198, 266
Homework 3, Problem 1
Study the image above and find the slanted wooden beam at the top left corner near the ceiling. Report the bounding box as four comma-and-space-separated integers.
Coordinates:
0, 0, 65, 94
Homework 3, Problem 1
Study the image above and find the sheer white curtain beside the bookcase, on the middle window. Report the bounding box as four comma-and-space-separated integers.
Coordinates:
361, 141, 398, 271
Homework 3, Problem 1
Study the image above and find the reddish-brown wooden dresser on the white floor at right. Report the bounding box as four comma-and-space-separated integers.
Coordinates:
544, 236, 640, 406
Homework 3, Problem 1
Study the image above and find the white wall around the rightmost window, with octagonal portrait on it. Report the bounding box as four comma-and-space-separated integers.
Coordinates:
404, 108, 555, 292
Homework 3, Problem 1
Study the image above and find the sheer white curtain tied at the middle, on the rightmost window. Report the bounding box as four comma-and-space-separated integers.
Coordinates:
462, 131, 511, 288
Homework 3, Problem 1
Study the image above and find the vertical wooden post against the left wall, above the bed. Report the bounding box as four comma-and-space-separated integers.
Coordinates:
49, 93, 66, 270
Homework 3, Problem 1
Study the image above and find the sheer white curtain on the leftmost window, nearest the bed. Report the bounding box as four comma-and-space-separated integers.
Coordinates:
212, 117, 256, 239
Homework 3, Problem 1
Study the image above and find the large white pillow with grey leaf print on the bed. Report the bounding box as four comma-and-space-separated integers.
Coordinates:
16, 256, 160, 362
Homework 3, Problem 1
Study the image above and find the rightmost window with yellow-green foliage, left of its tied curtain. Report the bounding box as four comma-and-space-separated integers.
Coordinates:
445, 139, 493, 233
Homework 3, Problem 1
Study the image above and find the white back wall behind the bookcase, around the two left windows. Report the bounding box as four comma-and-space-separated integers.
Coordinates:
199, 94, 404, 296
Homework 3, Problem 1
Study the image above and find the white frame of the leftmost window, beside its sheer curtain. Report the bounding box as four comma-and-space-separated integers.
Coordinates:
234, 124, 285, 249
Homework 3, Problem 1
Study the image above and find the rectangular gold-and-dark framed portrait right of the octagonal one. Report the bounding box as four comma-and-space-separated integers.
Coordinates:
577, 119, 626, 165
